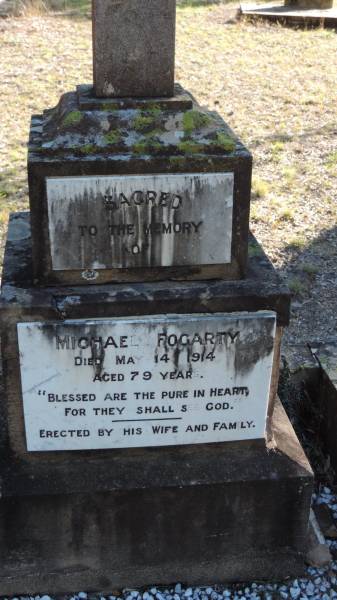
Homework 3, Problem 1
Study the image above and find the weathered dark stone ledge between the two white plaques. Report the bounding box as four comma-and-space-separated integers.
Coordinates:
0, 212, 290, 326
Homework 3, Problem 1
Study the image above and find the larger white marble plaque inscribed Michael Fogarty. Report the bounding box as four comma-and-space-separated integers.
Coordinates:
18, 311, 275, 451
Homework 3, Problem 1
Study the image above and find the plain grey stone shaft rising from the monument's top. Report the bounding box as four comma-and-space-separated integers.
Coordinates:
93, 0, 176, 98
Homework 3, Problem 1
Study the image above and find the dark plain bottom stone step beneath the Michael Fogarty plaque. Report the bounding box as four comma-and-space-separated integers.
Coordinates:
0, 404, 312, 595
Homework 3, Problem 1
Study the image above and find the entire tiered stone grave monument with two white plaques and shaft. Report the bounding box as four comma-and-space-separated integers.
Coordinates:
0, 0, 312, 595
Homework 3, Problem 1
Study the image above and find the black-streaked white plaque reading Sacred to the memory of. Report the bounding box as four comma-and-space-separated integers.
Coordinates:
46, 173, 234, 270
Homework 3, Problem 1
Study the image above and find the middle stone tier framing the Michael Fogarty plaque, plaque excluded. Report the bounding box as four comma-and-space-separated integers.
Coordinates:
0, 213, 290, 460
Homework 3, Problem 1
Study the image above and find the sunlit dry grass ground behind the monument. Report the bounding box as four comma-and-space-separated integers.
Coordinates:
0, 0, 337, 344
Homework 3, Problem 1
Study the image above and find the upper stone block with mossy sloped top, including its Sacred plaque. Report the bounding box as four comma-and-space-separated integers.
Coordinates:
28, 86, 252, 285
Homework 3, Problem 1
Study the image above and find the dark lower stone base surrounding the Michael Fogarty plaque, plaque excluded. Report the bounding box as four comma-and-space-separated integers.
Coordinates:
0, 214, 312, 594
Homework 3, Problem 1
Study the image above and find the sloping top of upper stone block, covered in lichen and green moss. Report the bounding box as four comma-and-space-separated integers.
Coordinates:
30, 92, 240, 160
